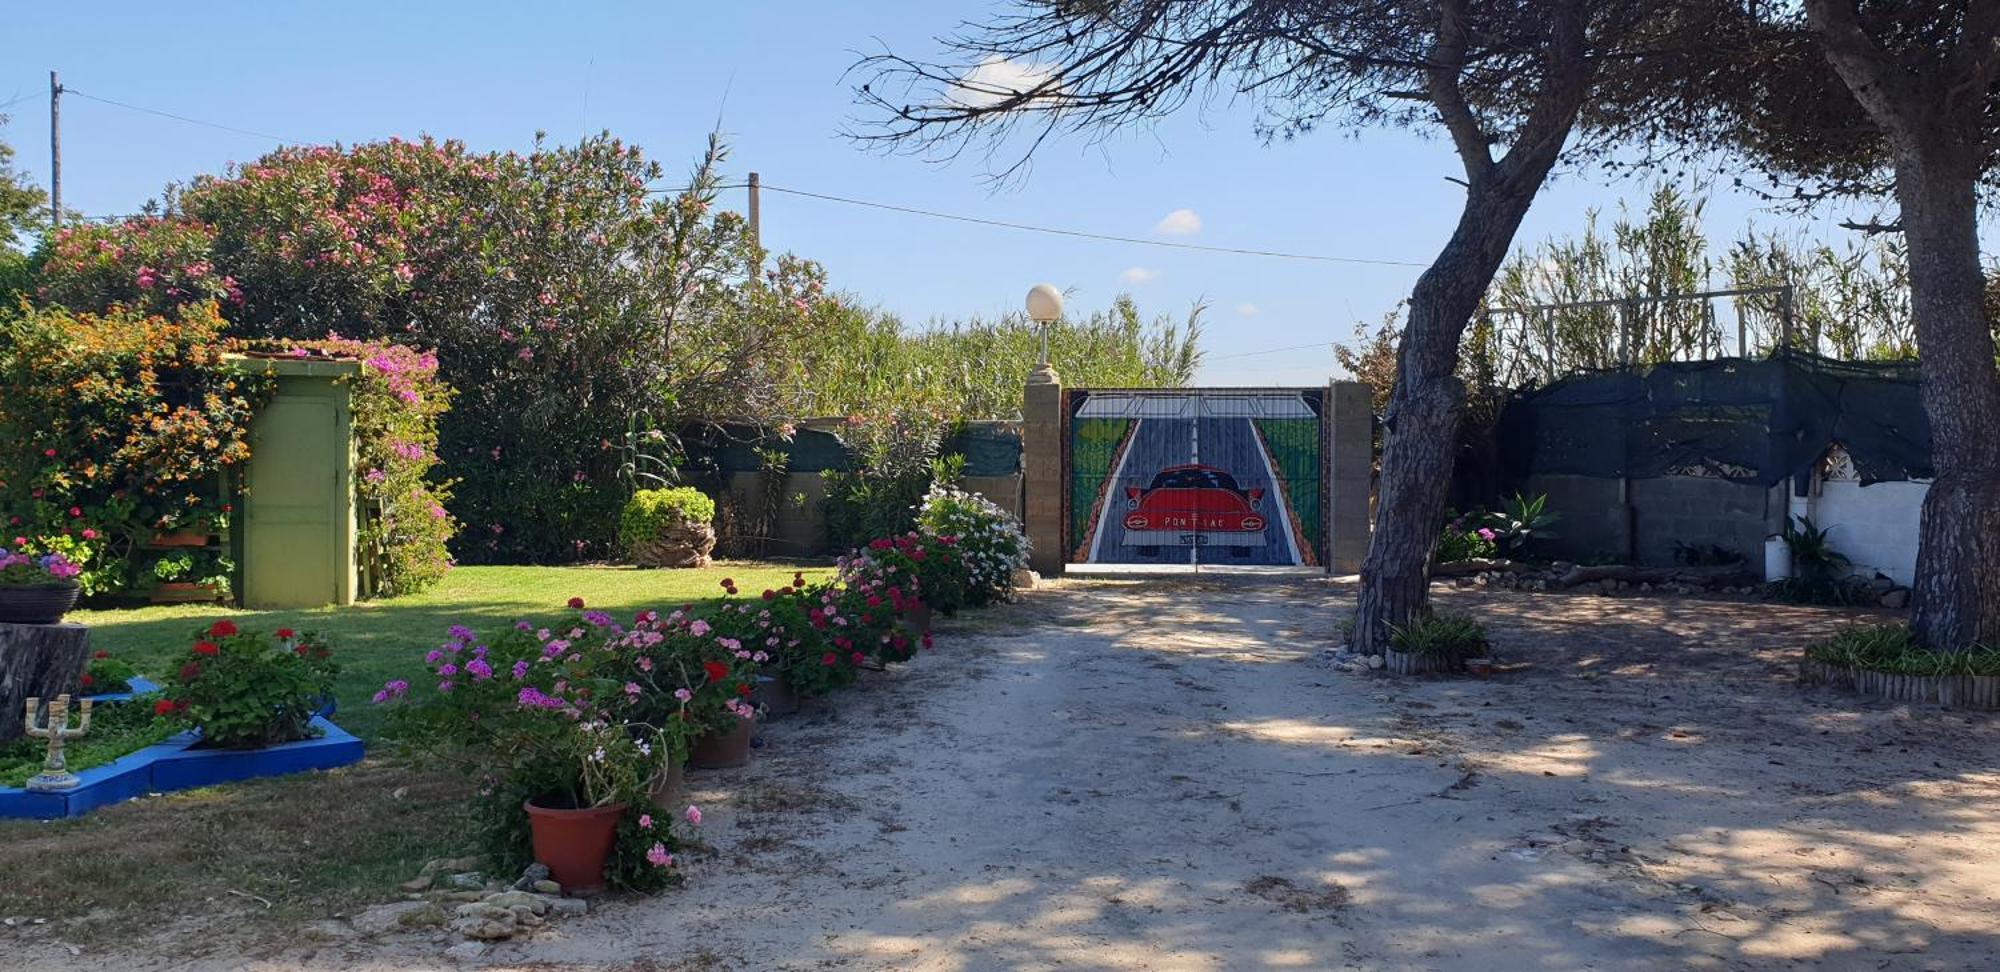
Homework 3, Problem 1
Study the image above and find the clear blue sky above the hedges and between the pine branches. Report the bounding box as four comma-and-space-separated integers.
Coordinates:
0, 0, 1944, 384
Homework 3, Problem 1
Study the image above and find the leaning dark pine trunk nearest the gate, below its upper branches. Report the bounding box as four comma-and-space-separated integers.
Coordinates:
1348, 176, 1556, 654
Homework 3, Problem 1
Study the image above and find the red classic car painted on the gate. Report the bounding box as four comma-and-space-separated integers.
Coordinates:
1124, 466, 1264, 556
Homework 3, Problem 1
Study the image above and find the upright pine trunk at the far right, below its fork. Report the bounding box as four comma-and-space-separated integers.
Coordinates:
1896, 154, 2000, 652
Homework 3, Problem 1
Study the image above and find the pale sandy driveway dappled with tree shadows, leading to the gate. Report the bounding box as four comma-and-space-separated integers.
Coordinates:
19, 580, 2000, 972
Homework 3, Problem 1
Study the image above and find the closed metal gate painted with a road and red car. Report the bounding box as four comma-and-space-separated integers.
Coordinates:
1064, 388, 1328, 570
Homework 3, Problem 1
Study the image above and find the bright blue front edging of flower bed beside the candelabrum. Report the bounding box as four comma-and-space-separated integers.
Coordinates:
0, 718, 362, 820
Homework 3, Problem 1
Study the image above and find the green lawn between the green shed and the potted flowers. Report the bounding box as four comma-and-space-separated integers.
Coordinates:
68, 562, 828, 736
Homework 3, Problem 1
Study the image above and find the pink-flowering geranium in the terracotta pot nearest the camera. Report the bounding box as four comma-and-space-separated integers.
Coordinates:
376, 612, 686, 890
